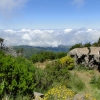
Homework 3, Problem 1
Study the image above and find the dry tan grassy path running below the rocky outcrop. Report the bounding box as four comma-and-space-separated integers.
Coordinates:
70, 66, 100, 100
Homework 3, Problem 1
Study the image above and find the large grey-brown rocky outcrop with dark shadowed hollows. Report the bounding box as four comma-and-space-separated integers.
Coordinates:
68, 47, 100, 71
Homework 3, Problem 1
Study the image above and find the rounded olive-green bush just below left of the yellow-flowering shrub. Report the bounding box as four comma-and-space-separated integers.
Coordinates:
45, 61, 70, 84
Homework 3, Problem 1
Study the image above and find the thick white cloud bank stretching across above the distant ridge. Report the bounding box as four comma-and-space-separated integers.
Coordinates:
0, 29, 100, 47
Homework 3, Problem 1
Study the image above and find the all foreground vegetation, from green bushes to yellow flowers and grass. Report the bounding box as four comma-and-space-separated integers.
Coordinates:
0, 37, 100, 100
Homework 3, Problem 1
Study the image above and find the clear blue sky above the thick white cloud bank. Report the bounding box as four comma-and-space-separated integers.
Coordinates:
0, 0, 100, 29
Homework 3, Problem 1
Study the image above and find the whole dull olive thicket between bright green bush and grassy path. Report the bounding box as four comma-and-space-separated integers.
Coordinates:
35, 61, 70, 92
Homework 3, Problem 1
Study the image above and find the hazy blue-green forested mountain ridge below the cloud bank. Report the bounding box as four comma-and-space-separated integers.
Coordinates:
13, 45, 70, 58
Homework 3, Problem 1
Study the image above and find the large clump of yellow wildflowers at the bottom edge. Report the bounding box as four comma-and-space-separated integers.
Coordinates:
44, 85, 75, 100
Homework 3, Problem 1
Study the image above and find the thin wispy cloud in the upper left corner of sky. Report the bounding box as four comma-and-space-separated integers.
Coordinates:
0, 0, 28, 15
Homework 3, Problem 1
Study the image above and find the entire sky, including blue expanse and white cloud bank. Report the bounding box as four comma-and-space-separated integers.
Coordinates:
0, 0, 100, 46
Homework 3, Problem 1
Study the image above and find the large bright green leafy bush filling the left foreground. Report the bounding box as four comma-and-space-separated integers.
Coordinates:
0, 54, 36, 96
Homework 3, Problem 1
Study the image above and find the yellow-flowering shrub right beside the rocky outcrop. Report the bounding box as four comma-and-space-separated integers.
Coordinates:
60, 56, 74, 69
